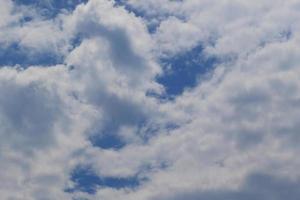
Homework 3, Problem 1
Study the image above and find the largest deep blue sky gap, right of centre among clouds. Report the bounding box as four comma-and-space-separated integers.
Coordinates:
157, 45, 217, 99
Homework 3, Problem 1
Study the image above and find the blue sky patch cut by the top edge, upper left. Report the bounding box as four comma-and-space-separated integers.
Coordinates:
14, 0, 88, 18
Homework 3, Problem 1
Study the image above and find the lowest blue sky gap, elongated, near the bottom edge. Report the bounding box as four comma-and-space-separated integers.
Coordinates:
65, 166, 142, 194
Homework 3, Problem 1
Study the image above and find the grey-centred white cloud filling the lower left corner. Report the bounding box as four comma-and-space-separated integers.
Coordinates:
0, 66, 94, 199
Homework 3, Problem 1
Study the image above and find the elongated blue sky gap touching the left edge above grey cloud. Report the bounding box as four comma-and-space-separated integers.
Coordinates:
0, 43, 63, 68
